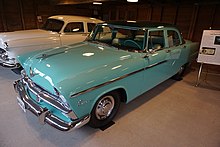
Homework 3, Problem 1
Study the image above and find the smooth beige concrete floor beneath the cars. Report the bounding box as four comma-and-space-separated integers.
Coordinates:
0, 64, 220, 147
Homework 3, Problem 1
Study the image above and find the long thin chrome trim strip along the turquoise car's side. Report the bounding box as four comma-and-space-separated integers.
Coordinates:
70, 60, 167, 98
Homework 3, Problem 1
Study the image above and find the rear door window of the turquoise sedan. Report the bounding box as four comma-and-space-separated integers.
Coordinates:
167, 30, 180, 47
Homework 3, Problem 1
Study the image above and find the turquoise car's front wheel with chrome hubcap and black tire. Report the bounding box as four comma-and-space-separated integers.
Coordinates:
89, 91, 120, 128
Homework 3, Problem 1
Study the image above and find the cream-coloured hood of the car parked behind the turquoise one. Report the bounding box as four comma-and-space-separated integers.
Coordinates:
0, 29, 59, 47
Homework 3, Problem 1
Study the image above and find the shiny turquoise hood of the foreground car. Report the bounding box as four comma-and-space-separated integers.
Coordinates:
18, 42, 143, 96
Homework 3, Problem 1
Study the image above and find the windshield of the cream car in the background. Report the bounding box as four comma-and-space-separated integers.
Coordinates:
42, 19, 64, 32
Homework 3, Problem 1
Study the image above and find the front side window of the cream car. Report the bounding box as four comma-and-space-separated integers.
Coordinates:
64, 22, 84, 33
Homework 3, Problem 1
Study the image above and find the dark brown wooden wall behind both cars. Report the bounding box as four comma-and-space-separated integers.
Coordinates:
0, 0, 220, 41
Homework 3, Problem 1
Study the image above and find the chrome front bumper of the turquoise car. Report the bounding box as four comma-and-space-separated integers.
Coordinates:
14, 80, 90, 131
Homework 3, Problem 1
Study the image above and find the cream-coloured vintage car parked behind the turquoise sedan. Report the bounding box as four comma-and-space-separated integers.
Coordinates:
0, 15, 102, 71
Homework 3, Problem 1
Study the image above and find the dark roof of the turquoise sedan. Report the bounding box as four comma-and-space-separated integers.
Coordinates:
102, 21, 176, 28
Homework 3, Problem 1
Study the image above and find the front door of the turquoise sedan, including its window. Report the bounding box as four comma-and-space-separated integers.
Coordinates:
143, 30, 170, 91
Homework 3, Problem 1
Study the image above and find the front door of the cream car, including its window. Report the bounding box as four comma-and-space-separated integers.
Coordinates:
60, 22, 87, 45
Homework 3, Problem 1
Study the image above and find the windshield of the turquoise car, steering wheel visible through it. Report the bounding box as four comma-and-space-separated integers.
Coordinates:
87, 25, 145, 52
